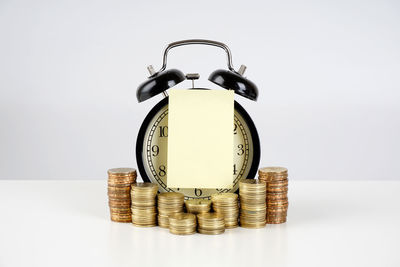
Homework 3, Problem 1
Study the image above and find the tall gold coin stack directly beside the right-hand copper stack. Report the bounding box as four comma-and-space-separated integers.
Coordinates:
239, 179, 267, 228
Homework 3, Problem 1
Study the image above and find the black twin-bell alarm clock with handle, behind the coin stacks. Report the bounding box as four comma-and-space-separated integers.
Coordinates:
136, 39, 260, 199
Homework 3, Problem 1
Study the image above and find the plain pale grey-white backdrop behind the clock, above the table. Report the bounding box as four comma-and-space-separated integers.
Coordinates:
0, 0, 400, 180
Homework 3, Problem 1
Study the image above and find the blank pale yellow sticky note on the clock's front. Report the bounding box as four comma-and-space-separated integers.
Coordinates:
167, 89, 234, 188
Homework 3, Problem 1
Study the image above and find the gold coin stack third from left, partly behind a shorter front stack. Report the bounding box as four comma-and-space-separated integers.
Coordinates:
158, 192, 185, 228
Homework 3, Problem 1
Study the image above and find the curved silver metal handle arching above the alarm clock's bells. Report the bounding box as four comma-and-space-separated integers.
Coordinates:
158, 39, 238, 72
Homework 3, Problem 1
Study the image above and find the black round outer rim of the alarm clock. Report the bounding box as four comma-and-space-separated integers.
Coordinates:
136, 95, 261, 192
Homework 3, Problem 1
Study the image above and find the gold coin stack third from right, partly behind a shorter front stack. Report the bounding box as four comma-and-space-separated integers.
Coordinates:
211, 193, 239, 228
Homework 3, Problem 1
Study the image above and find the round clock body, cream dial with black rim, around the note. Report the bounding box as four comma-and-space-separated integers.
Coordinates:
136, 96, 260, 199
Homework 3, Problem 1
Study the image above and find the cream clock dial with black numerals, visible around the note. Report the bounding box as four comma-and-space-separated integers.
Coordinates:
142, 105, 253, 198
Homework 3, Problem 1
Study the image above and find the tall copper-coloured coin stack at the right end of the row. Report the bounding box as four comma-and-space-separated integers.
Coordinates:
258, 167, 289, 224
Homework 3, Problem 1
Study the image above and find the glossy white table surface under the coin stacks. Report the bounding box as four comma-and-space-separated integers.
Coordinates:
0, 180, 400, 267
